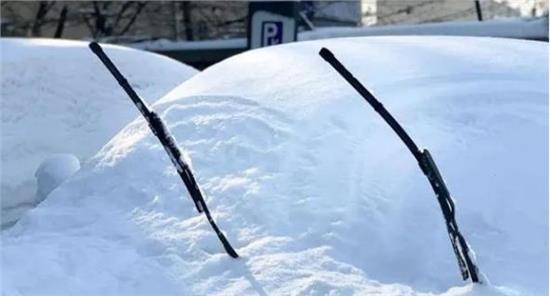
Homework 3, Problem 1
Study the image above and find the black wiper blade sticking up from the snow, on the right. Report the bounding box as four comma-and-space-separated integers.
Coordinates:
319, 48, 481, 283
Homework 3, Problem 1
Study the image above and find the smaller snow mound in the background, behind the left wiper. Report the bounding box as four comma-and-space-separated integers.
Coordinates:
0, 38, 197, 227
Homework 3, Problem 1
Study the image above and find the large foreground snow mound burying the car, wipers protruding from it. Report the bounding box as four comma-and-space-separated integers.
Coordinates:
2, 37, 548, 295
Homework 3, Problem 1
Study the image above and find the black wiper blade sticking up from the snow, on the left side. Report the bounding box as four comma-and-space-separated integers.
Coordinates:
89, 42, 239, 258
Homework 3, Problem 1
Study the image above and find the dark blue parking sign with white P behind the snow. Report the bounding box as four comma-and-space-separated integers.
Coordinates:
248, 1, 298, 49
